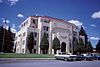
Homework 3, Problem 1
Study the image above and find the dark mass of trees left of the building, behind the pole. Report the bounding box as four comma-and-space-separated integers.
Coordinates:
0, 26, 15, 52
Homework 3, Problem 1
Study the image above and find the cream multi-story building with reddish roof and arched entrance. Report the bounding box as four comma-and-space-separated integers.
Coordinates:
15, 16, 78, 54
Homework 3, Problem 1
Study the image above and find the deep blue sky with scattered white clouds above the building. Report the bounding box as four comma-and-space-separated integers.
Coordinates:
0, 0, 100, 47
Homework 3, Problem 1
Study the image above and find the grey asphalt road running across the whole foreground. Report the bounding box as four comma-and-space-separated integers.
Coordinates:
0, 60, 100, 67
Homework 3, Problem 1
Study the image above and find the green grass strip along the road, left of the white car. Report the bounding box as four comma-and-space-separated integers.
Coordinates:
0, 53, 54, 58
